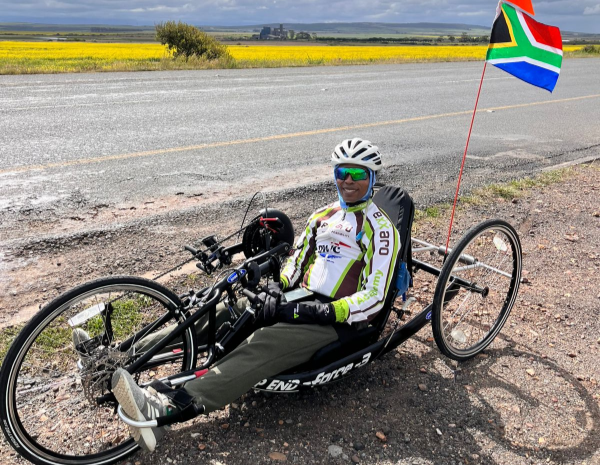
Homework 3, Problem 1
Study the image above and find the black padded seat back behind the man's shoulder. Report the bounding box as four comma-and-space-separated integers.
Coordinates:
371, 186, 415, 332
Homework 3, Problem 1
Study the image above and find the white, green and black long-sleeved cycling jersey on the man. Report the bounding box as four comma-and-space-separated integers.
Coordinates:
281, 200, 400, 323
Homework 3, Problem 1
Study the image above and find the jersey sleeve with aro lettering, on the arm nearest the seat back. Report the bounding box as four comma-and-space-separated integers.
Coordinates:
333, 209, 400, 323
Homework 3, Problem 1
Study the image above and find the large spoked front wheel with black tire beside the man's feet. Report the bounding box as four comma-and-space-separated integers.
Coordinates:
0, 276, 196, 465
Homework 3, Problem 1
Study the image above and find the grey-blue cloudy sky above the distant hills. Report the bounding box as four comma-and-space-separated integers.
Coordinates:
0, 0, 600, 33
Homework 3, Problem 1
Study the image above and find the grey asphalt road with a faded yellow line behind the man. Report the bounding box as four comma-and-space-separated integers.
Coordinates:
0, 59, 600, 238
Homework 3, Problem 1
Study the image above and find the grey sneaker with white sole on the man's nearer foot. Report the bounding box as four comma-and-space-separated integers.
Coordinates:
112, 368, 179, 452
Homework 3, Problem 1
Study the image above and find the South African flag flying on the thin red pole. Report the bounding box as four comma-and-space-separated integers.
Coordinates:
486, 2, 563, 92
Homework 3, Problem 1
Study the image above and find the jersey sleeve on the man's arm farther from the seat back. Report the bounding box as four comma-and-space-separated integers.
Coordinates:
281, 206, 333, 289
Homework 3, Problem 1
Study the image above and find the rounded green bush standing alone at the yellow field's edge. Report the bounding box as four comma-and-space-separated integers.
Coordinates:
155, 21, 230, 60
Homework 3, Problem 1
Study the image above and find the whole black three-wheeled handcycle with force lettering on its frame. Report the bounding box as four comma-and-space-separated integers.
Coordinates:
0, 186, 522, 465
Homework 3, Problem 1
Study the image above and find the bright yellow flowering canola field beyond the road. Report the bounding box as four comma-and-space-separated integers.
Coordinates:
0, 42, 580, 74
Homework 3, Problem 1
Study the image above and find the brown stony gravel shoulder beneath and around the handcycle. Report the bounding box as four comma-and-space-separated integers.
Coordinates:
0, 163, 600, 465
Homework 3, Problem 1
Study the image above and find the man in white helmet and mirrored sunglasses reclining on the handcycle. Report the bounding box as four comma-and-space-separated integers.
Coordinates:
112, 138, 400, 451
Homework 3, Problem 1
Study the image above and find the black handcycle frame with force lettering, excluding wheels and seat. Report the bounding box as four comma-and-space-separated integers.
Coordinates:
112, 227, 506, 427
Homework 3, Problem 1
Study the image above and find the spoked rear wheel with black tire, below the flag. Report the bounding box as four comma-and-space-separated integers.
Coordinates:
431, 220, 522, 361
